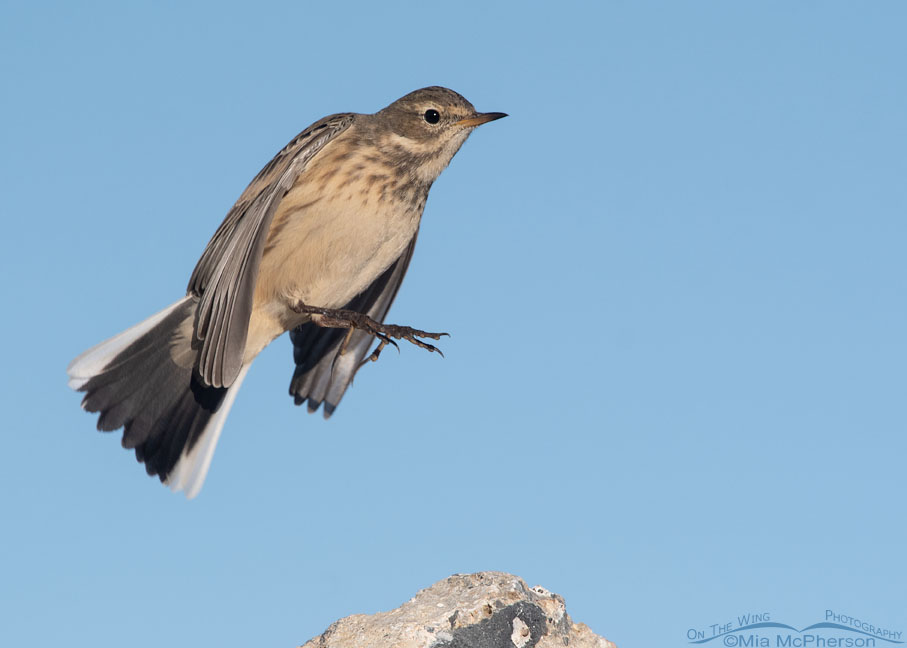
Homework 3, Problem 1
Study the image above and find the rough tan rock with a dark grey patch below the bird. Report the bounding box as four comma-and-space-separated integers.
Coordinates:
302, 572, 615, 648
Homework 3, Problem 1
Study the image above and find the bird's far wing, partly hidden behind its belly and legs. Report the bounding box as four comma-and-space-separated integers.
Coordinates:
290, 230, 416, 418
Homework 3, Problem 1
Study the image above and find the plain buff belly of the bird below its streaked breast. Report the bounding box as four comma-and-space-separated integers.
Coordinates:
245, 192, 421, 360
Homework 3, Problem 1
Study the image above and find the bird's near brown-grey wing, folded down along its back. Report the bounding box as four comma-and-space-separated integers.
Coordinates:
187, 114, 353, 387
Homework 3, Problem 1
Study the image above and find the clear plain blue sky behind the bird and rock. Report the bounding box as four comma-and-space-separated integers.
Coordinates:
0, 1, 907, 648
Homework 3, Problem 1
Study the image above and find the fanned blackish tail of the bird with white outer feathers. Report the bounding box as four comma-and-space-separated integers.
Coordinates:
67, 297, 248, 498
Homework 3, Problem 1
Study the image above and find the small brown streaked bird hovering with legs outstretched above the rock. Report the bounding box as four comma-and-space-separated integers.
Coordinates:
67, 86, 507, 499
